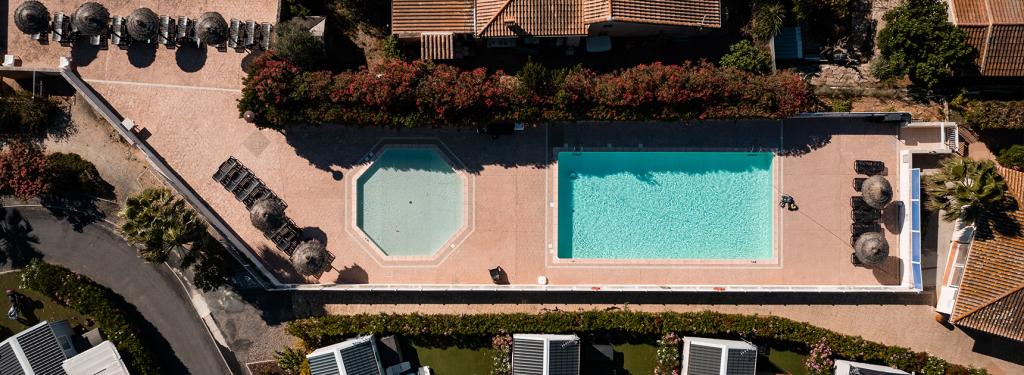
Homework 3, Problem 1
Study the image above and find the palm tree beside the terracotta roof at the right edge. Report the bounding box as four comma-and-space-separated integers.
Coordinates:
925, 158, 1007, 221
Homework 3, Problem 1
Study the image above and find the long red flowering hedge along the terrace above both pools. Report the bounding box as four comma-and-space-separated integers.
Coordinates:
239, 54, 818, 128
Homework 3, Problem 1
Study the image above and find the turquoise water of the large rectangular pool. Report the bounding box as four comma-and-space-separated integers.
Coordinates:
558, 152, 774, 259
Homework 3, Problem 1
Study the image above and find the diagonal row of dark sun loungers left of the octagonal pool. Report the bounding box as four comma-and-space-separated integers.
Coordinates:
213, 157, 301, 255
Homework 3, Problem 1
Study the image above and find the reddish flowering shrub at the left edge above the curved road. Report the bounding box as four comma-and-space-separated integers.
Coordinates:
0, 142, 49, 199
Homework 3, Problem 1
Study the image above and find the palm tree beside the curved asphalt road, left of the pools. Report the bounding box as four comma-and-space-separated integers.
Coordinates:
118, 189, 206, 261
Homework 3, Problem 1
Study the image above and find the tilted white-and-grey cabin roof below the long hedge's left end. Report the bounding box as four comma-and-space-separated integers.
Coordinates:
306, 336, 384, 375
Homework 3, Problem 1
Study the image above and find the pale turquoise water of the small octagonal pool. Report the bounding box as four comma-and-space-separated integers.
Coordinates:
356, 149, 465, 256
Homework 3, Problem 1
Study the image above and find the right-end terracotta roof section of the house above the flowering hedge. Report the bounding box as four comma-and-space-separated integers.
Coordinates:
611, 0, 722, 28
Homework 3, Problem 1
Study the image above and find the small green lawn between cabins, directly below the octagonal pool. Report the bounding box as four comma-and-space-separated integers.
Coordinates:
402, 341, 490, 375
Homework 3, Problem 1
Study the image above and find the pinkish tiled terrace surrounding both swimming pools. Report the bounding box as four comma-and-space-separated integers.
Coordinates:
8, 1, 901, 287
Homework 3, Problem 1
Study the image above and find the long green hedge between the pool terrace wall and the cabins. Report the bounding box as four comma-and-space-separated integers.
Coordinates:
288, 311, 987, 374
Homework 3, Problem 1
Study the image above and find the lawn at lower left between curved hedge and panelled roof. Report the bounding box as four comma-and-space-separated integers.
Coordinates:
0, 272, 85, 340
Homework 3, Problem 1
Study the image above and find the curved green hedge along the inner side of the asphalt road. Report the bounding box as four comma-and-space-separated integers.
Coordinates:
22, 259, 160, 375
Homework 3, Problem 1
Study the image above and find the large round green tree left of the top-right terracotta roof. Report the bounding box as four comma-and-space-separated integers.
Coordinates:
872, 0, 975, 88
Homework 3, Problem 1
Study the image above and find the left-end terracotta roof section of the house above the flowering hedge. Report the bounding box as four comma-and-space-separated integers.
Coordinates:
391, 0, 473, 37
